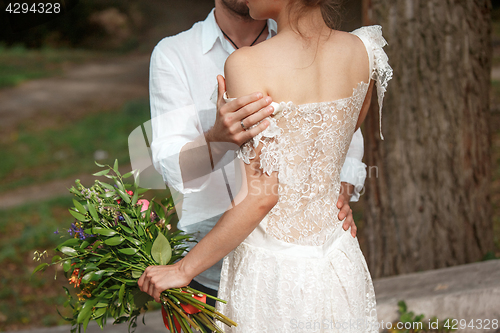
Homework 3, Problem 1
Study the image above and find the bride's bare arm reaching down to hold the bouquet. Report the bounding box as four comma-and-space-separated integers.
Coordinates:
138, 48, 278, 302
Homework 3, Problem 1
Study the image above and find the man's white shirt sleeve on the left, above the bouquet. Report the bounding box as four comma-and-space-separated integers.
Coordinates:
149, 44, 211, 194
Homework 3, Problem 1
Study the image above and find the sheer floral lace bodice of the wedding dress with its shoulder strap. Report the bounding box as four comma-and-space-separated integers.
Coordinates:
225, 26, 392, 245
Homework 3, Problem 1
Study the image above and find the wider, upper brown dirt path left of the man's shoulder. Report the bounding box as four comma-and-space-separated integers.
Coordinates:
0, 55, 149, 132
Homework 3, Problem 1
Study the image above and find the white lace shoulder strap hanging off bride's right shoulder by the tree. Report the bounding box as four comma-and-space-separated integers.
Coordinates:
351, 25, 392, 140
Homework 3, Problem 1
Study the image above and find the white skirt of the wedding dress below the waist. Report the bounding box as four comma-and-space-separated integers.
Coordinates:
217, 230, 378, 333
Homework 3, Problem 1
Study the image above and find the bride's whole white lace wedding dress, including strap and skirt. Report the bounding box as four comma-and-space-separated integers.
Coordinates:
217, 26, 392, 333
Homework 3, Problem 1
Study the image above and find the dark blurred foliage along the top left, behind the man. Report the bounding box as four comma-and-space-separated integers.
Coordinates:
0, 0, 213, 52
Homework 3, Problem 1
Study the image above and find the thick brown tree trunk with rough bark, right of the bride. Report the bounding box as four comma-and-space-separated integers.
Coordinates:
363, 0, 494, 277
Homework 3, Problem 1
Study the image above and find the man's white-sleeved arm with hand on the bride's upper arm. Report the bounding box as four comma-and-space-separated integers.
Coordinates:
150, 46, 272, 193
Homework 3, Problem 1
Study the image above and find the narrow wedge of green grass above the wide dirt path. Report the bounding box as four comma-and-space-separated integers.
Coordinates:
0, 45, 106, 88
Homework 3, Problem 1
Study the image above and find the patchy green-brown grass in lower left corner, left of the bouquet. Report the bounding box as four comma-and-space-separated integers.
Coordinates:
0, 197, 72, 331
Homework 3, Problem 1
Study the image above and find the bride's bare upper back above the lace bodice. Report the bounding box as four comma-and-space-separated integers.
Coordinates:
226, 30, 369, 104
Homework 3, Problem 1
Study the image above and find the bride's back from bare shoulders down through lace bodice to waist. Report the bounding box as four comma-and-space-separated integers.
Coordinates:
226, 29, 376, 245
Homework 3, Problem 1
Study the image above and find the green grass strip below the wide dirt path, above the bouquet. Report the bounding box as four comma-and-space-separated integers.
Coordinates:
0, 100, 150, 192
